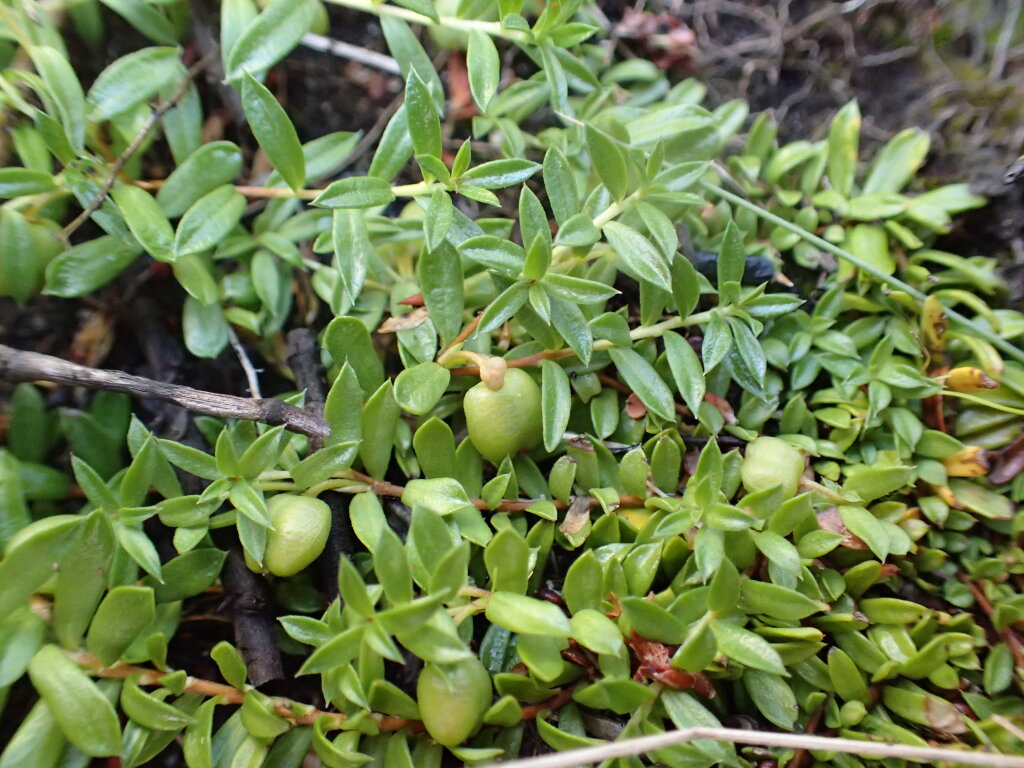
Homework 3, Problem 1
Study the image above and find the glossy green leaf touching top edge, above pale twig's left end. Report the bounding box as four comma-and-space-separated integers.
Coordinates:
224, 0, 319, 81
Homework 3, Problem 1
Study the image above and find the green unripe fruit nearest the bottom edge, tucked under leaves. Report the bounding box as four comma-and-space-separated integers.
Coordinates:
416, 656, 492, 746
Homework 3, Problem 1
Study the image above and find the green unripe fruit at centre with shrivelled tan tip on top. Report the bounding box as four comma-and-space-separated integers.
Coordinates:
463, 368, 541, 465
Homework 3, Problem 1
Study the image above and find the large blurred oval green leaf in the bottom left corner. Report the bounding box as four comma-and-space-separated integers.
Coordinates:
29, 645, 121, 757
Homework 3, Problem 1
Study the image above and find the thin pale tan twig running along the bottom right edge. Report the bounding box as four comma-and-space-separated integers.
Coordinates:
488, 727, 1024, 768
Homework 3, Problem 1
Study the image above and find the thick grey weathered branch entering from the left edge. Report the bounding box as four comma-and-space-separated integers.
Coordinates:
0, 344, 331, 437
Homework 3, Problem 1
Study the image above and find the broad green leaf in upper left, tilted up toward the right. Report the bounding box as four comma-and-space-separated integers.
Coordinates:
86, 47, 185, 123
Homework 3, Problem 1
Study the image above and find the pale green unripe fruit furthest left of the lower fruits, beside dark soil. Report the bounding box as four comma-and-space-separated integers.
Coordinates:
263, 494, 331, 577
